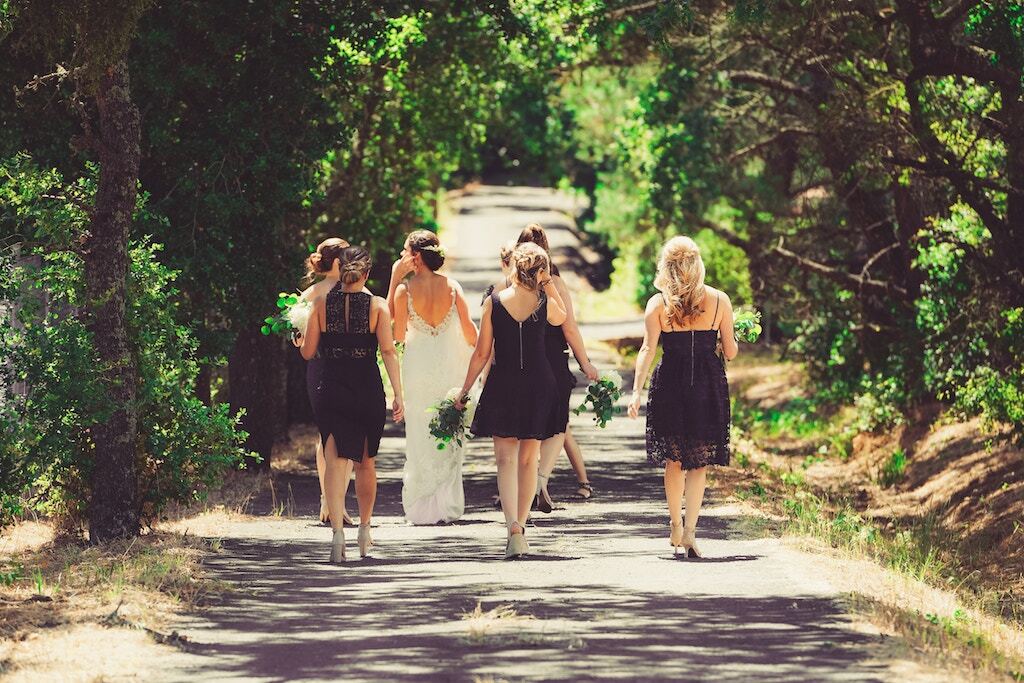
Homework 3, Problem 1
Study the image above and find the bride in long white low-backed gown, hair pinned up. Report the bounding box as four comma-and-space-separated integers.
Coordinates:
388, 230, 476, 524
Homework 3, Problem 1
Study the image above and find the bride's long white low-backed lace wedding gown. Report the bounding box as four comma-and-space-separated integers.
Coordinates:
401, 291, 473, 524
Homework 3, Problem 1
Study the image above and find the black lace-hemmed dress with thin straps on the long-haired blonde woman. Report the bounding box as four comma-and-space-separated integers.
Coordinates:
647, 290, 731, 470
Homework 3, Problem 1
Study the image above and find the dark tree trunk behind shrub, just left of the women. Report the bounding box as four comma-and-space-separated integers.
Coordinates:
227, 326, 288, 469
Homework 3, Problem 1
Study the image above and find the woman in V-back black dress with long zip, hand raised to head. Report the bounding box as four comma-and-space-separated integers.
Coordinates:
461, 244, 565, 558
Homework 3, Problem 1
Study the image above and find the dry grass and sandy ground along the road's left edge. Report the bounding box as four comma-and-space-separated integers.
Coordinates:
0, 523, 230, 680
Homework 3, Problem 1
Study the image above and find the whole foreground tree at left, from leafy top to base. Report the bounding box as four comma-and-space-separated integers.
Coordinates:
4, 0, 150, 543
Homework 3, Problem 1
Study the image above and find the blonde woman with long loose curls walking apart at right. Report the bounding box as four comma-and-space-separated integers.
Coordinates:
629, 237, 739, 557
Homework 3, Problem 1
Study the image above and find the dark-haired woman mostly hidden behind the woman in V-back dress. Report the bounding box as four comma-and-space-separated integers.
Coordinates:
519, 223, 598, 513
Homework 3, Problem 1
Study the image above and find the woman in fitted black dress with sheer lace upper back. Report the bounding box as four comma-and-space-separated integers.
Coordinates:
301, 247, 404, 562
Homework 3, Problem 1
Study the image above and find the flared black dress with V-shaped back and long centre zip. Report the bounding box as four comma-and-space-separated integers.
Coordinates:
470, 293, 556, 439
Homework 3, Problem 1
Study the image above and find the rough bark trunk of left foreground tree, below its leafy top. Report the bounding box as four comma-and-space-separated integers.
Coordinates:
84, 59, 140, 543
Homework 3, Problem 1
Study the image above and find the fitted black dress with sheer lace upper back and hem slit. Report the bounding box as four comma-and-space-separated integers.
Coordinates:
307, 284, 387, 462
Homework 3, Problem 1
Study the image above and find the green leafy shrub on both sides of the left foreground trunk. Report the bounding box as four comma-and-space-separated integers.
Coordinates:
0, 157, 249, 526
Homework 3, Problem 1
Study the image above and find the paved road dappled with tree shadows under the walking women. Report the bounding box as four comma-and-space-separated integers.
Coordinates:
157, 187, 929, 681
